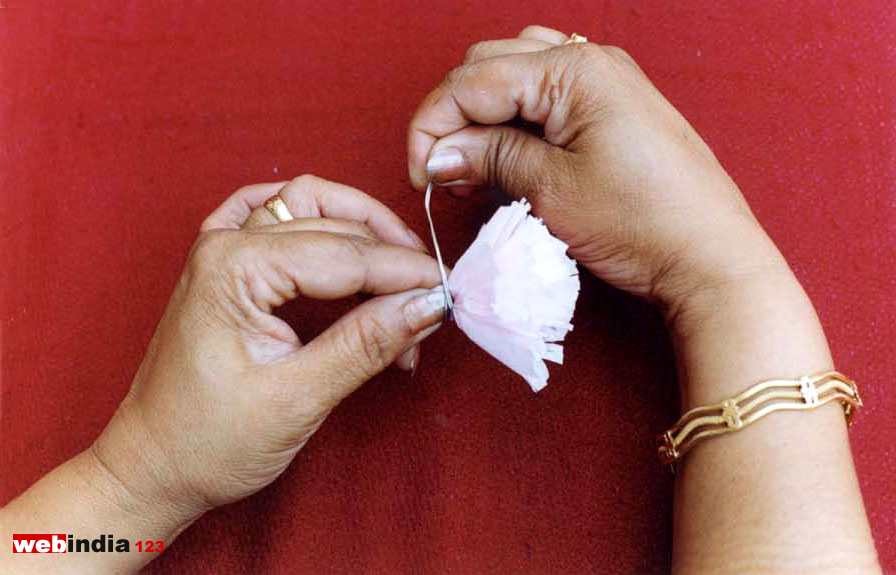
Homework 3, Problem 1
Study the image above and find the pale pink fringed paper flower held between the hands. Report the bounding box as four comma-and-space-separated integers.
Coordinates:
448, 200, 579, 391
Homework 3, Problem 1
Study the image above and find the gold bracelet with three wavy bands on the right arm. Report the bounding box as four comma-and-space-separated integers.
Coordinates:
658, 371, 862, 470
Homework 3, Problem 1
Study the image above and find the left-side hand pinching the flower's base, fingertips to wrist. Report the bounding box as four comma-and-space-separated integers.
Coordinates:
93, 176, 444, 523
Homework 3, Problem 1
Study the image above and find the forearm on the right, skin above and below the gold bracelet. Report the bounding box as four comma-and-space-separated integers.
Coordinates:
670, 269, 879, 574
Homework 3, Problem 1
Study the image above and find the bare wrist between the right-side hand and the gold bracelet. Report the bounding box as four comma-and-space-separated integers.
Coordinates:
666, 259, 834, 409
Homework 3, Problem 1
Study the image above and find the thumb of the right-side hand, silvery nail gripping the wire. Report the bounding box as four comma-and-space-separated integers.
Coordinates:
426, 126, 566, 203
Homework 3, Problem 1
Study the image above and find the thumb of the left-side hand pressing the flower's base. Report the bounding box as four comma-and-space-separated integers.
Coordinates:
294, 286, 445, 405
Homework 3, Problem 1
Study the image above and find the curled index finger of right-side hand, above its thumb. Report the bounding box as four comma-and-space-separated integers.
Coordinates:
408, 49, 596, 189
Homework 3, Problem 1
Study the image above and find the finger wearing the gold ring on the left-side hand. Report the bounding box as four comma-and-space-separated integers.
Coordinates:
246, 175, 426, 251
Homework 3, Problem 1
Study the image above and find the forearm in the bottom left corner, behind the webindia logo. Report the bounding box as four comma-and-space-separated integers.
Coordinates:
0, 432, 195, 574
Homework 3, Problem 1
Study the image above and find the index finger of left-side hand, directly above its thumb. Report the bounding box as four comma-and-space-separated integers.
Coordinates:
214, 231, 441, 313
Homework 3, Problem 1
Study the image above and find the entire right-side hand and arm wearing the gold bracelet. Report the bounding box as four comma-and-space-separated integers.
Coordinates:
408, 27, 880, 573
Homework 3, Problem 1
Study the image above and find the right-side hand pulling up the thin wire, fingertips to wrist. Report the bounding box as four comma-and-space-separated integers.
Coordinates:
408, 26, 790, 313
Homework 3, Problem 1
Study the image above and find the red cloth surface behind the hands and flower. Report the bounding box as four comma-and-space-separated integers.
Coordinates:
0, 0, 896, 574
